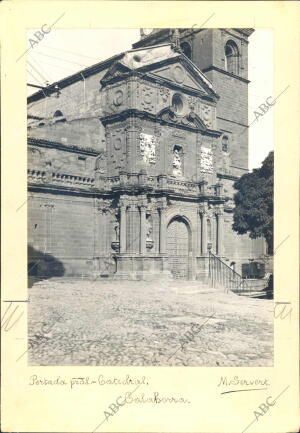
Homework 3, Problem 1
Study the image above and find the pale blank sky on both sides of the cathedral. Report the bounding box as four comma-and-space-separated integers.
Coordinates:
26, 29, 275, 170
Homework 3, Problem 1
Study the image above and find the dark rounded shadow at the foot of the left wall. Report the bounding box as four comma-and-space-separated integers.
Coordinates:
27, 245, 65, 288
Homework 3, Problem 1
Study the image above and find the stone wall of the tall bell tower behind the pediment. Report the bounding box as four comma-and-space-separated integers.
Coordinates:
193, 29, 248, 176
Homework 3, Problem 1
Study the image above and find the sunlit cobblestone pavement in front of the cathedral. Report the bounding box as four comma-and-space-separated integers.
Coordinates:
28, 280, 273, 366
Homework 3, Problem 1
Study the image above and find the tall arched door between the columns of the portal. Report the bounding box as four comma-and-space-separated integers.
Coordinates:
167, 217, 190, 280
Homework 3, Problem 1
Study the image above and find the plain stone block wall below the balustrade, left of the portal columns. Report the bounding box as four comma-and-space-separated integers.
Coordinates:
28, 193, 95, 276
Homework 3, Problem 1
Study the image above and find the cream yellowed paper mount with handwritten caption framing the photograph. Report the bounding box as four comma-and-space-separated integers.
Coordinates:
0, 1, 300, 433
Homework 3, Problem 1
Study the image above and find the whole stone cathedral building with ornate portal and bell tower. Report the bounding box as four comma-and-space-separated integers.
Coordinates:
28, 29, 264, 281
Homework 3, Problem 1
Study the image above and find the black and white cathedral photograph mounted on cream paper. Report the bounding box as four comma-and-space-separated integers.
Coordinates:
26, 26, 274, 367
